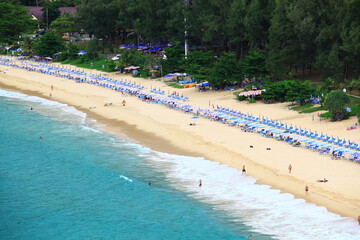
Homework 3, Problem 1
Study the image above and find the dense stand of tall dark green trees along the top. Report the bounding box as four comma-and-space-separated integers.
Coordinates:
4, 0, 360, 81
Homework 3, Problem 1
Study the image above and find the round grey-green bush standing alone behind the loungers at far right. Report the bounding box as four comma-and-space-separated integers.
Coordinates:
323, 90, 350, 121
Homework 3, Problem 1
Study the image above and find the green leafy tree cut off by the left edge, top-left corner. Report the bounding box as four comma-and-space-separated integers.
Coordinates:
0, 1, 37, 43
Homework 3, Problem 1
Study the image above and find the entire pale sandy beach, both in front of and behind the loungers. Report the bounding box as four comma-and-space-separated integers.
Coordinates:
0, 58, 360, 221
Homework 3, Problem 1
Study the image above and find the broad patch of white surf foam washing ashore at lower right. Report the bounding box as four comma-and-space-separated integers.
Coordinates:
142, 151, 360, 240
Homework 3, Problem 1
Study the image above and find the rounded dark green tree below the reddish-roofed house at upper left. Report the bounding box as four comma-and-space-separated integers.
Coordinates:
34, 32, 64, 57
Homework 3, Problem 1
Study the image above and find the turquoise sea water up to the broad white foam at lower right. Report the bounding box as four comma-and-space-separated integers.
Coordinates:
0, 90, 270, 240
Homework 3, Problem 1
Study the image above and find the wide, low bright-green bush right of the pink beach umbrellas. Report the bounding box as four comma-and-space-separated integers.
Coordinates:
261, 80, 317, 105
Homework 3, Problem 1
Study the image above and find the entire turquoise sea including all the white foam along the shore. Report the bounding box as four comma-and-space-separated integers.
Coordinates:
0, 89, 360, 240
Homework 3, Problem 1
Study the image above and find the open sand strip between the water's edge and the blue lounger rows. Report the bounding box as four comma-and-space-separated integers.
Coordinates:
0, 60, 360, 221
